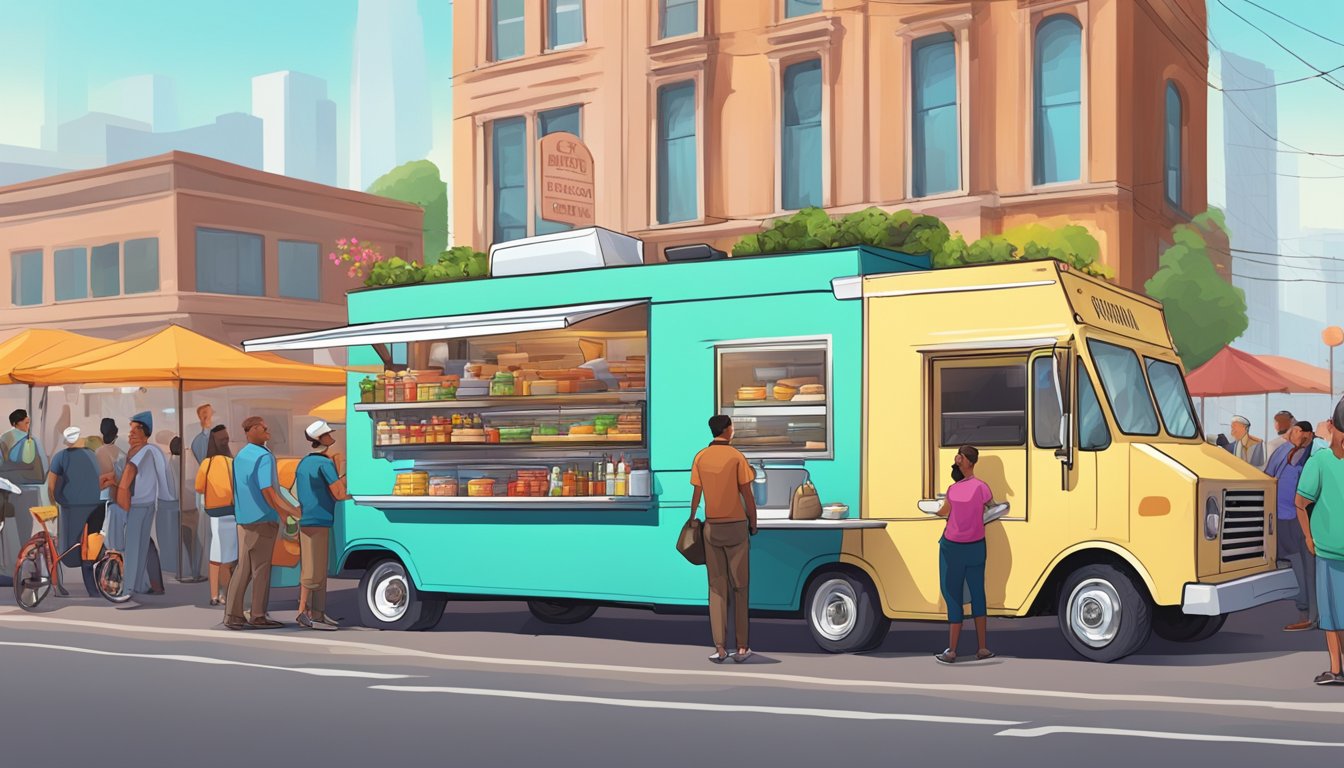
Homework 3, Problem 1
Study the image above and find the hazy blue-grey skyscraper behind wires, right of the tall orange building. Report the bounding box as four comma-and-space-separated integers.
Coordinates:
1222, 51, 1279, 354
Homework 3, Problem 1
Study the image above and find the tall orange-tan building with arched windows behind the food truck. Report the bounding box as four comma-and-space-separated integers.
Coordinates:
453, 0, 1208, 286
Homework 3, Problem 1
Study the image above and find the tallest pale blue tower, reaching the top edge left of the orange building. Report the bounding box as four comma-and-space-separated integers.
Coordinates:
349, 0, 433, 190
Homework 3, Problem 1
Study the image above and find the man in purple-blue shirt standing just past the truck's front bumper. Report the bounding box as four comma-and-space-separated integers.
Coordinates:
1265, 421, 1316, 632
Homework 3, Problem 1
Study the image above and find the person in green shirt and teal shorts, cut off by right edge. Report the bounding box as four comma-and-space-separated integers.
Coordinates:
1297, 399, 1344, 686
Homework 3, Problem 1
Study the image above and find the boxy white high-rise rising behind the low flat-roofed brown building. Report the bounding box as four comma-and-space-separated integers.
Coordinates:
253, 71, 336, 184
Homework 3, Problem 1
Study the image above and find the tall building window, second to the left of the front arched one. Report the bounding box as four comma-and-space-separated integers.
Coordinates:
780, 59, 821, 211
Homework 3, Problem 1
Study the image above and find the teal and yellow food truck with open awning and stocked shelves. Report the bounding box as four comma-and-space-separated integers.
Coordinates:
246, 229, 1297, 662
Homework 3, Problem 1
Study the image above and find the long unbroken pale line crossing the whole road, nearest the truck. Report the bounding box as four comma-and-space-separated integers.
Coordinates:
0, 613, 1344, 714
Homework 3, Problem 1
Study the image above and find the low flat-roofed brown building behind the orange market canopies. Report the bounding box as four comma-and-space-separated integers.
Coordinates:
0, 152, 423, 349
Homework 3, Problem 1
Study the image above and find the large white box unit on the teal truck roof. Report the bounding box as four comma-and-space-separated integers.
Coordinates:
491, 227, 644, 277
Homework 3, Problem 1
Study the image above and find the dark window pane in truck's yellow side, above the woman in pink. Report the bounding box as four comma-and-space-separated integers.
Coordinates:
939, 363, 1027, 448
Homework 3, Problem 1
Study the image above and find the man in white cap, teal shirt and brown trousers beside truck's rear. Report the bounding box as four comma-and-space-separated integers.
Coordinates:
294, 418, 349, 631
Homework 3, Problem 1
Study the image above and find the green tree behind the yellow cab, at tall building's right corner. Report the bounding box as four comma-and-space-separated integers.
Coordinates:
1144, 208, 1249, 370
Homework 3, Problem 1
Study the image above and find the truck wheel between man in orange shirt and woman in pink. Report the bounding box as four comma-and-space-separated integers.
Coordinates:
802, 570, 891, 654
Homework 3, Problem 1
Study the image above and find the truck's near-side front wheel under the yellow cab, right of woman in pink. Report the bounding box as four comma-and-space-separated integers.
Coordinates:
1058, 565, 1153, 662
